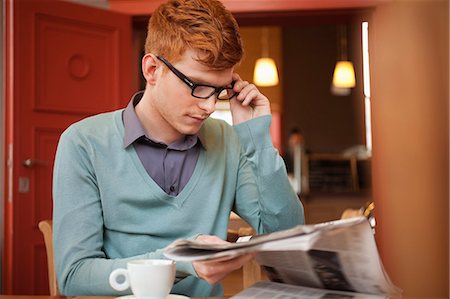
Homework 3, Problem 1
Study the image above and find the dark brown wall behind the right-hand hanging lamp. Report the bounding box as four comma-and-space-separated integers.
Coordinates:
283, 24, 364, 153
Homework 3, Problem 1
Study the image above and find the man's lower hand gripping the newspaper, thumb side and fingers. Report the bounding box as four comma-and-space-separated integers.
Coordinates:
192, 235, 254, 284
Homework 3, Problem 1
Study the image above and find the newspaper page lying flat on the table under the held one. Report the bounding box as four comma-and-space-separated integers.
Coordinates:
230, 281, 388, 299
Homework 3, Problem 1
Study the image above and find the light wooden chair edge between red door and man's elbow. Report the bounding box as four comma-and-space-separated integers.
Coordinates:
39, 220, 60, 296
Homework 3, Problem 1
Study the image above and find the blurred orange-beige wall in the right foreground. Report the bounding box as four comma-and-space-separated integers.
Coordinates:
369, 0, 449, 298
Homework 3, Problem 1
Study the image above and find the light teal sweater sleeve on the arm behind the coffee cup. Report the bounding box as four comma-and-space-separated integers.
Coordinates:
53, 128, 195, 296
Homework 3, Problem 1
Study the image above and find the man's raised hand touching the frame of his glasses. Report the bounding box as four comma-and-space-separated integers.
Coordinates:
230, 73, 270, 125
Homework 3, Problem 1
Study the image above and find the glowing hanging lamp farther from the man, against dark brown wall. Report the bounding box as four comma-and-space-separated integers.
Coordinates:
331, 25, 356, 95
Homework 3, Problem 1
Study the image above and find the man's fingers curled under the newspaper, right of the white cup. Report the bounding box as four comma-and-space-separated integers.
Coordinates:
192, 253, 254, 284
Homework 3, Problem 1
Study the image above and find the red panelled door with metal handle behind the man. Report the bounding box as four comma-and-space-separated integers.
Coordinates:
3, 0, 137, 294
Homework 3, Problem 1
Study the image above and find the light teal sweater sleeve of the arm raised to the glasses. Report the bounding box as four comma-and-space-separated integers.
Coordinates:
234, 115, 304, 234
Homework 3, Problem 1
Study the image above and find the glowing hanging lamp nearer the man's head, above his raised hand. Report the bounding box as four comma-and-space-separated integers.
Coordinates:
253, 27, 278, 86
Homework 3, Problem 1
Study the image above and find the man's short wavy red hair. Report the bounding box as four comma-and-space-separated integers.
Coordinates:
145, 0, 244, 70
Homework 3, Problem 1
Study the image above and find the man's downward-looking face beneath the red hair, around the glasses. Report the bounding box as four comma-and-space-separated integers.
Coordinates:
152, 50, 233, 142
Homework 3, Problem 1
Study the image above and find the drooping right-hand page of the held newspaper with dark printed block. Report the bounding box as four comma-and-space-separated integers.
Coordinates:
256, 218, 401, 295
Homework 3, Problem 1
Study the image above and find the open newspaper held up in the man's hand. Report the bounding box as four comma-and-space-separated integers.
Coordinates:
165, 217, 401, 298
